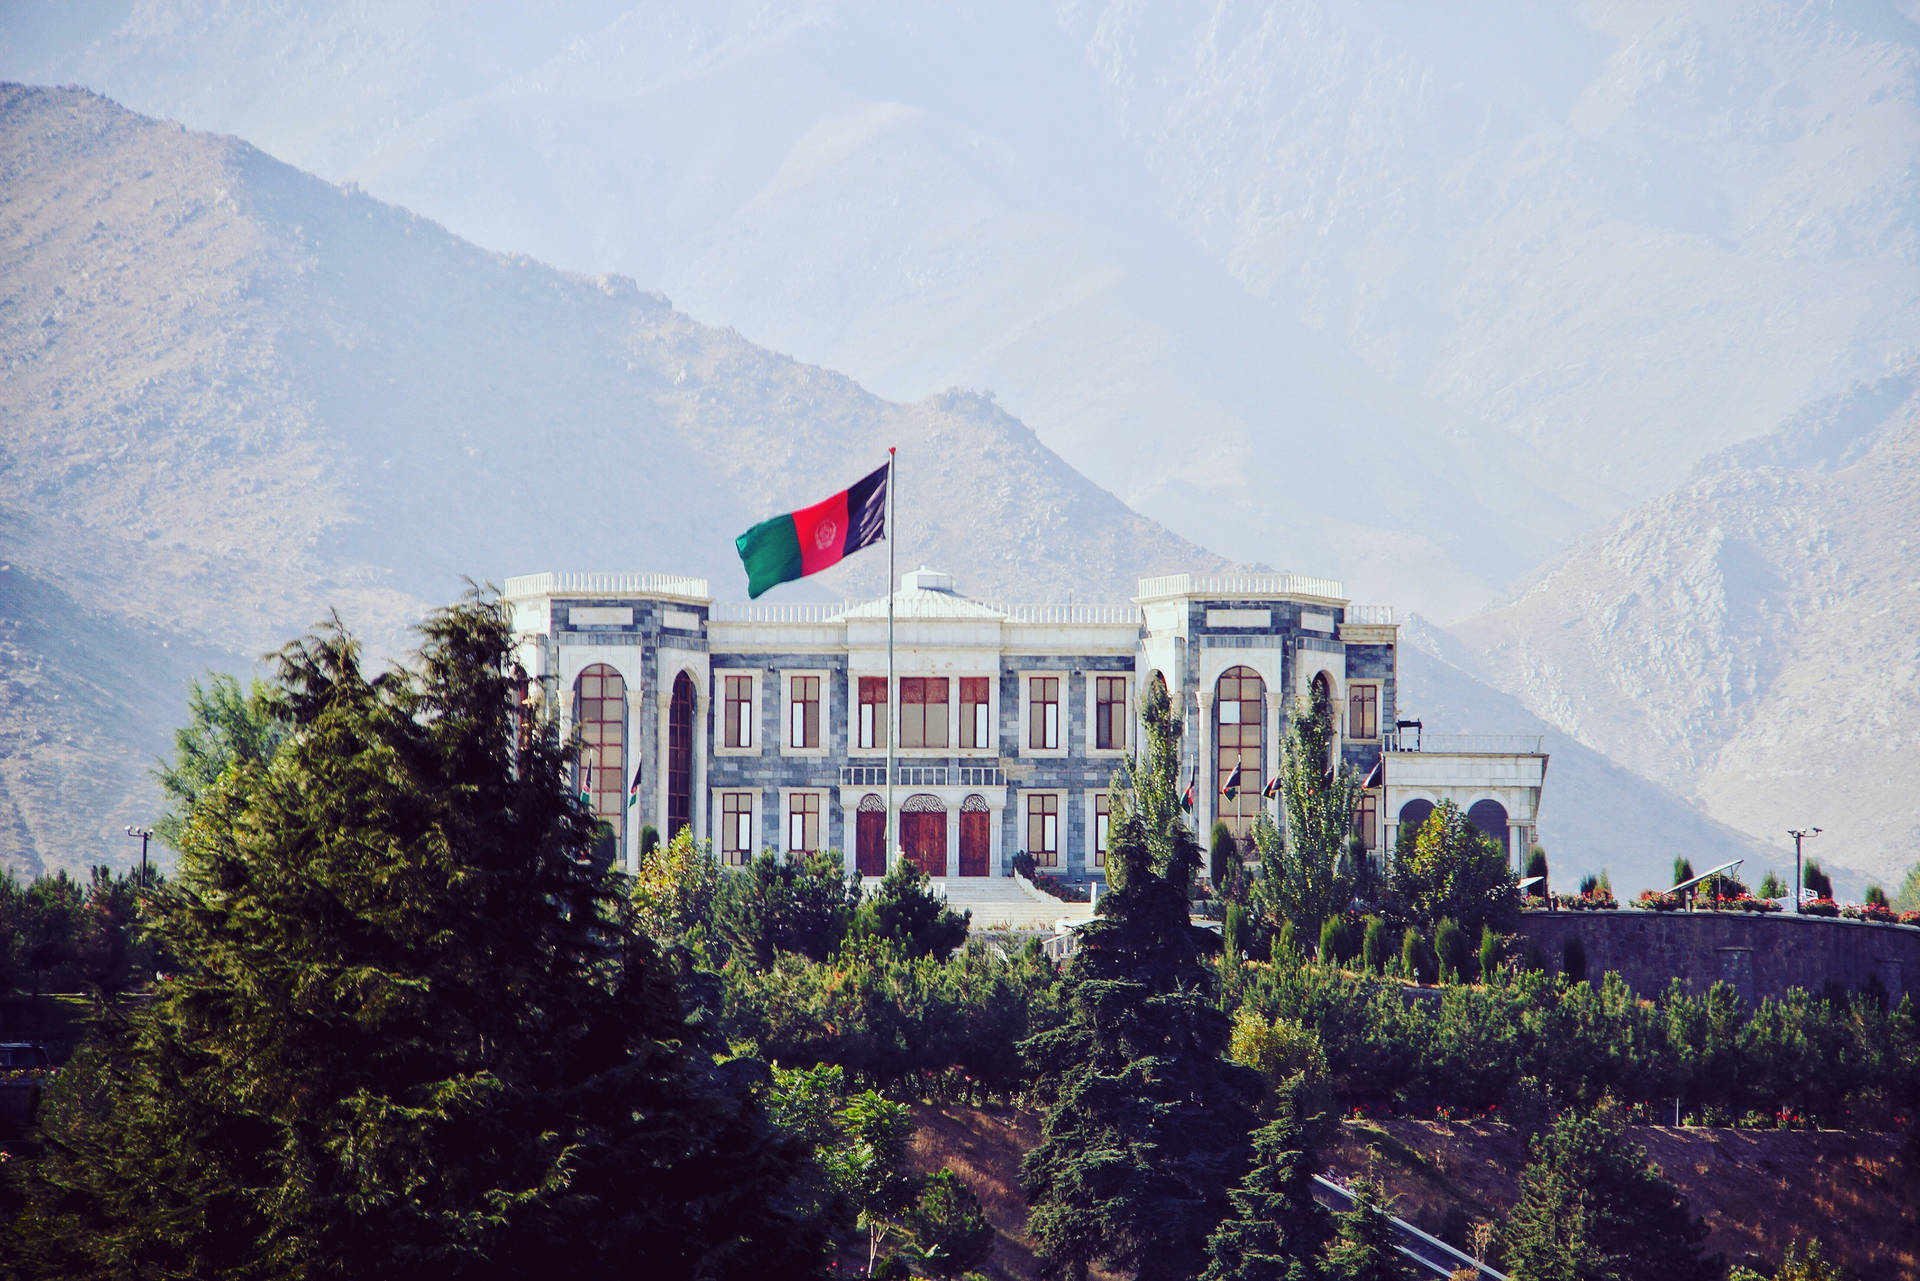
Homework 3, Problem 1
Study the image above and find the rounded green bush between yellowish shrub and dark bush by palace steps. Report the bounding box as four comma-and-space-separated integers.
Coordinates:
714, 853, 860, 970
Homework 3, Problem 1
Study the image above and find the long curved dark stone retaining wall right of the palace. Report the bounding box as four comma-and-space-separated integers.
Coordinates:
1521, 908, 1920, 1001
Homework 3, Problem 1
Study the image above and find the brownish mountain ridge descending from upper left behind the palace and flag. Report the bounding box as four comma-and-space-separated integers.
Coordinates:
0, 86, 1223, 866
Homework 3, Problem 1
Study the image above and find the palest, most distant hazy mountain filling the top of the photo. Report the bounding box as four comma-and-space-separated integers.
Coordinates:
0, 0, 1920, 618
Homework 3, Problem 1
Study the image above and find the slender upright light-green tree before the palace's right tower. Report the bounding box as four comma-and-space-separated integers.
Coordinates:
1254, 701, 1363, 939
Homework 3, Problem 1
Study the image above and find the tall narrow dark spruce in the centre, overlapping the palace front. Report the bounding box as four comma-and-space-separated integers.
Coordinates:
1021, 686, 1260, 1281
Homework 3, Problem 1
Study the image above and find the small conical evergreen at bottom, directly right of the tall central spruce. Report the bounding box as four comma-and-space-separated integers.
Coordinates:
1202, 1089, 1332, 1281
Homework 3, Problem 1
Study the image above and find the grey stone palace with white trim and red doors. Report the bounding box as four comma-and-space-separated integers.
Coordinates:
503, 568, 1548, 882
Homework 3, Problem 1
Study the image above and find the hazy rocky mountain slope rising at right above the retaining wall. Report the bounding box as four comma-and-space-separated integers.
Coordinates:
1452, 369, 1920, 880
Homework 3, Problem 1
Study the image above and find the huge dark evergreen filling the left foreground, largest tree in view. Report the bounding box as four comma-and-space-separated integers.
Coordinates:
0, 599, 822, 1281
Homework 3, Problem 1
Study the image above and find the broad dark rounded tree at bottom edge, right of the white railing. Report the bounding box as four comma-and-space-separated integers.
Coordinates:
1503, 1104, 1722, 1281
